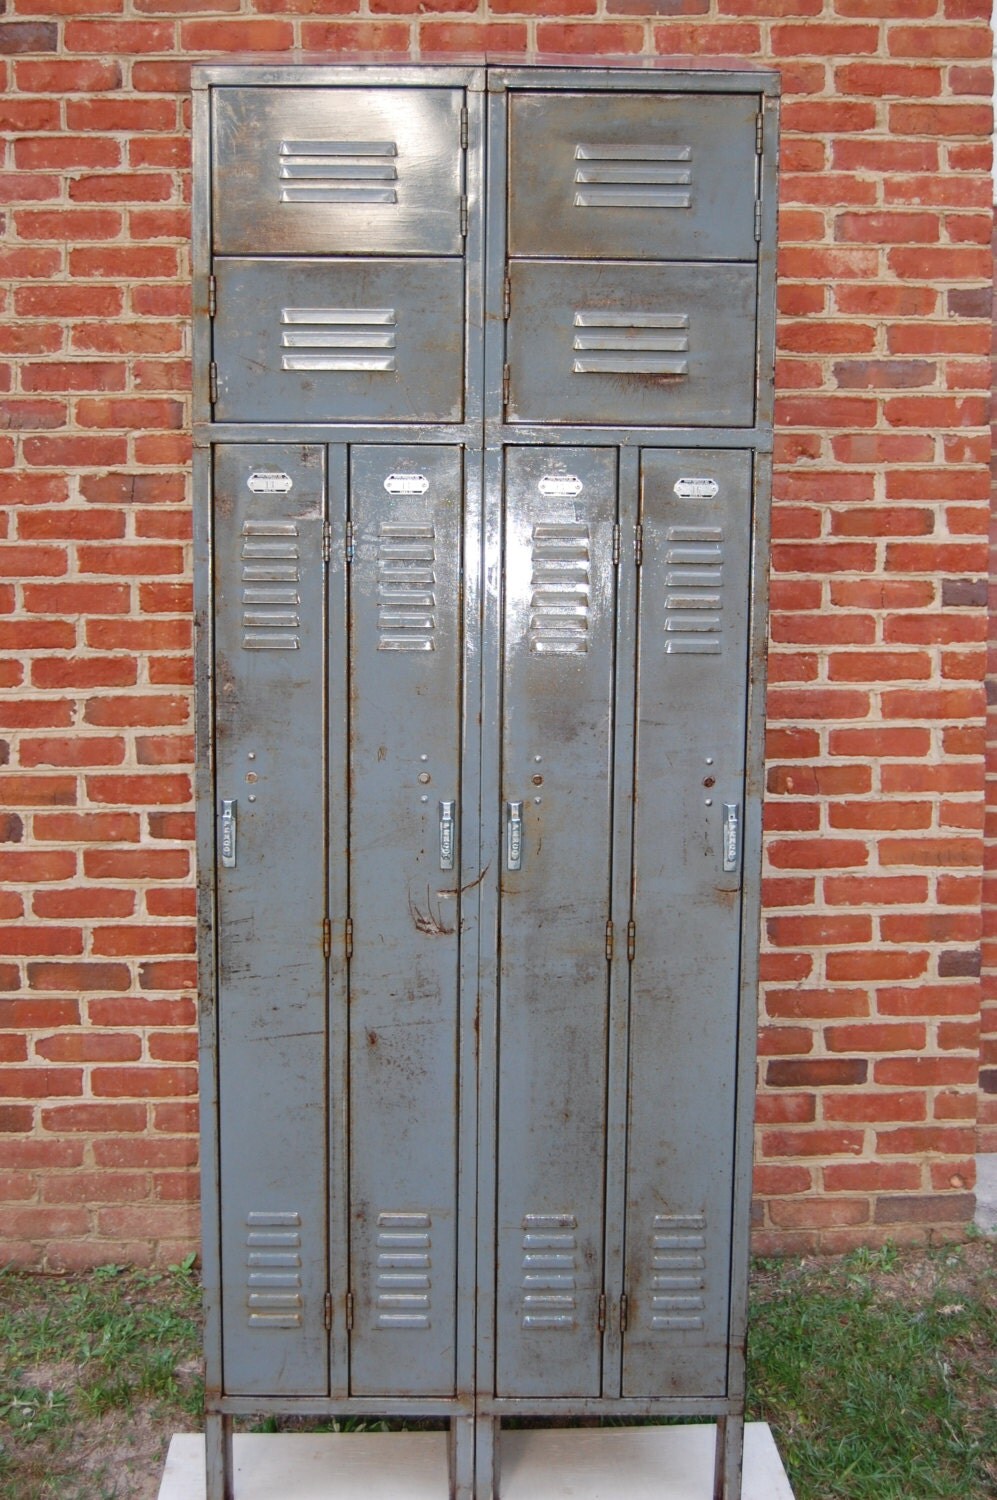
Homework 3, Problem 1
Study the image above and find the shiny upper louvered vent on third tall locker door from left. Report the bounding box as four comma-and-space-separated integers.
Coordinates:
529, 522, 592, 656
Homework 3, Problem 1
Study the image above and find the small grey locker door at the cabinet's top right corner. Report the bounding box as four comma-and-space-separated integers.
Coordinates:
508, 92, 760, 261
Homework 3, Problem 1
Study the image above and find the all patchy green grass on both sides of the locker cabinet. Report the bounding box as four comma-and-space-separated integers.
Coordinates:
0, 1239, 997, 1500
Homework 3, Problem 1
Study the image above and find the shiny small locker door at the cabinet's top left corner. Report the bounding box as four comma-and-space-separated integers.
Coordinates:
211, 87, 463, 255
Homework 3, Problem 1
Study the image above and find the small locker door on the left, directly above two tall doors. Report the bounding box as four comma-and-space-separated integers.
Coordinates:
214, 258, 463, 422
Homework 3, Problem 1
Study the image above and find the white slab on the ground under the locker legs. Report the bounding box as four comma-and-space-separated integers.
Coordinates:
159, 1422, 793, 1500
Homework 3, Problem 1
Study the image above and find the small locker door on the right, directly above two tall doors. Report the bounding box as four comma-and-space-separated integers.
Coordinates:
507, 261, 756, 426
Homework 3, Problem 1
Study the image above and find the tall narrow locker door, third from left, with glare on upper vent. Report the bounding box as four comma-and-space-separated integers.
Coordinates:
496, 449, 616, 1397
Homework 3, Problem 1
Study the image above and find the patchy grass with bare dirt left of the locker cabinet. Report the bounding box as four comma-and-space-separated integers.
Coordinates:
0, 1262, 202, 1500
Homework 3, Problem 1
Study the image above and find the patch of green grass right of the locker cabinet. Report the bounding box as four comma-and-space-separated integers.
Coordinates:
748, 1241, 997, 1500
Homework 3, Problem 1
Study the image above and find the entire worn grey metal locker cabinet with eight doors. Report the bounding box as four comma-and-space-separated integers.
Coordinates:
193, 65, 777, 1500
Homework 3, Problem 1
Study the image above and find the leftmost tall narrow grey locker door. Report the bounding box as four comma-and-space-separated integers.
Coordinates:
214, 446, 329, 1395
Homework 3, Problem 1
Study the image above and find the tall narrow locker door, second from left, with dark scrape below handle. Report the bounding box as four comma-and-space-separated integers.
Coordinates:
349, 446, 462, 1395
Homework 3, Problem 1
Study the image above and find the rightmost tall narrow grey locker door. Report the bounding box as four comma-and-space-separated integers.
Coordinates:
622, 450, 753, 1397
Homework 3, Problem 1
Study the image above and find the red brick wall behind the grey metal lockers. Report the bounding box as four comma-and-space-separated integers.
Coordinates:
0, 0, 991, 1266
